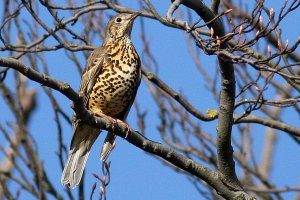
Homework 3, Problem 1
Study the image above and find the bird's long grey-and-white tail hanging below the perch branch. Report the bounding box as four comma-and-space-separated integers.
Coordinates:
61, 124, 100, 188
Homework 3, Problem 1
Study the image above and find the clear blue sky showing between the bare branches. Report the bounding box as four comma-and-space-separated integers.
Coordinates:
0, 0, 300, 200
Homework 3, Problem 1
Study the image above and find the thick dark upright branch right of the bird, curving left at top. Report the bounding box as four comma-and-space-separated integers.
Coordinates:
175, 0, 241, 190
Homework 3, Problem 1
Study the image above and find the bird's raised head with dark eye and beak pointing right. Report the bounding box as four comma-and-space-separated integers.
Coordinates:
106, 13, 141, 39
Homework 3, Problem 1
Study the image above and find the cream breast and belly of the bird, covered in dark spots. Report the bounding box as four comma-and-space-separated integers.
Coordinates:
89, 38, 141, 117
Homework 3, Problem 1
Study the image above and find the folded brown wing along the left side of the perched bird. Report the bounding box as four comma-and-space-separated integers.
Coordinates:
80, 47, 105, 106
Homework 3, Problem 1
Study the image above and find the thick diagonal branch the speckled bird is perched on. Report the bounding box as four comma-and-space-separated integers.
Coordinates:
0, 58, 244, 199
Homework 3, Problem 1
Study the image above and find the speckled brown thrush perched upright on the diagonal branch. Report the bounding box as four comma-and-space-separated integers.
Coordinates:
61, 13, 142, 189
